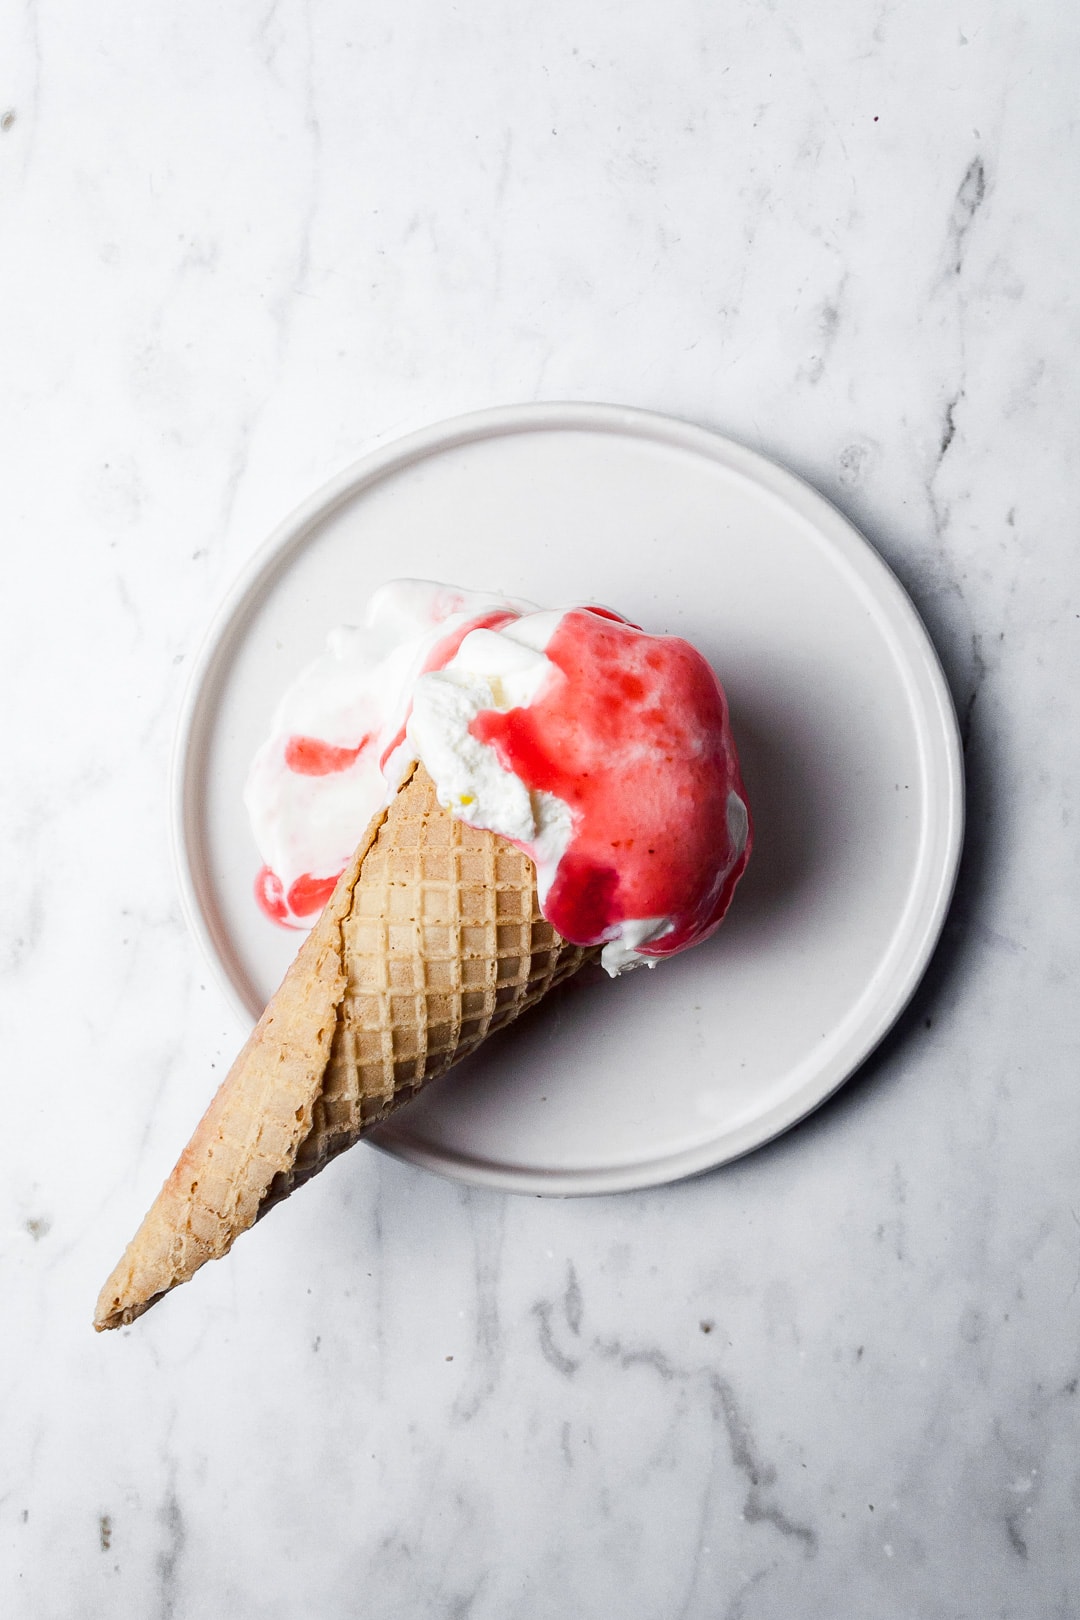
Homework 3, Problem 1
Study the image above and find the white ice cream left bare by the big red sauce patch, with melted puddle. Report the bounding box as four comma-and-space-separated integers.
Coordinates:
244, 580, 670, 975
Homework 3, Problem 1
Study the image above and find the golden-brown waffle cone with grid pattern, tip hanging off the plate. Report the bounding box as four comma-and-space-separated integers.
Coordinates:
94, 766, 594, 1330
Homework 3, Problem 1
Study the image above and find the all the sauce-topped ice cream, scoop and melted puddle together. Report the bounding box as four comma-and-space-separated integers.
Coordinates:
246, 582, 750, 974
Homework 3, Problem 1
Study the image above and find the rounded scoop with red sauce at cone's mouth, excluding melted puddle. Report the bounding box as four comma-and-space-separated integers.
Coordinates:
408, 608, 750, 974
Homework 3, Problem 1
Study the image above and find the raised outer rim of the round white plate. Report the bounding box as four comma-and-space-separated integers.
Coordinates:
168, 400, 965, 1197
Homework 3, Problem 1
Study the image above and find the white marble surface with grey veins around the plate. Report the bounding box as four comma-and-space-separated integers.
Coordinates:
0, 0, 1080, 1620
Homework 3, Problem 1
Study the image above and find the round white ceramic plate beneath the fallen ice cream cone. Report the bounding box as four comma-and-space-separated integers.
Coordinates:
173, 405, 963, 1194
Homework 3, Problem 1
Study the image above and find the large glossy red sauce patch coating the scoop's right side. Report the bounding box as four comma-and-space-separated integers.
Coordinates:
471, 608, 750, 956
